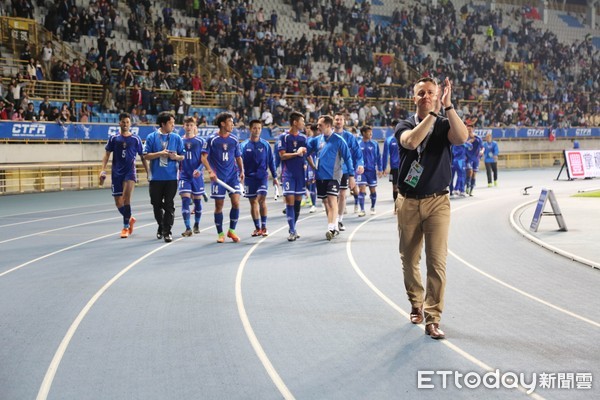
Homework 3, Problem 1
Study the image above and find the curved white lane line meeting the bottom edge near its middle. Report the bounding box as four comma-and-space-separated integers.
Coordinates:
235, 215, 316, 400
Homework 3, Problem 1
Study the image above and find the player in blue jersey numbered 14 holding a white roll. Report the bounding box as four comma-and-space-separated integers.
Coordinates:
202, 112, 244, 243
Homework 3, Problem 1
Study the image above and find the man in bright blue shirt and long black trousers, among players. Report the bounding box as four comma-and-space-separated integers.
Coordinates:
144, 111, 185, 243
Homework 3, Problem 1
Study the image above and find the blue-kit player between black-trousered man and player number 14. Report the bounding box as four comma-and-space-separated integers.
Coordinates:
179, 116, 204, 237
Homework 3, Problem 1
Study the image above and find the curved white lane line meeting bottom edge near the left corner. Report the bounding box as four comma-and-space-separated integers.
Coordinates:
36, 238, 183, 400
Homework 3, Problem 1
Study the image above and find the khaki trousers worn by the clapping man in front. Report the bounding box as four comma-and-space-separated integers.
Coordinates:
396, 195, 450, 324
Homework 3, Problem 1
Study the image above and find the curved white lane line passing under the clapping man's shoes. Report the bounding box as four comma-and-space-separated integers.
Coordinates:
346, 211, 544, 400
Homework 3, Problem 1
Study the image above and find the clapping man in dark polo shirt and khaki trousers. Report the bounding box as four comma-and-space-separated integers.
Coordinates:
395, 77, 467, 339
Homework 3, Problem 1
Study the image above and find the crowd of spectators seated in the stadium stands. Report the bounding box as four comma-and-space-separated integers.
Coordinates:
0, 0, 600, 127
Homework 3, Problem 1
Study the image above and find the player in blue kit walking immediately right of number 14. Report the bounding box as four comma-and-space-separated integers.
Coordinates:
241, 119, 277, 236
